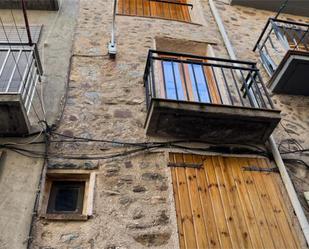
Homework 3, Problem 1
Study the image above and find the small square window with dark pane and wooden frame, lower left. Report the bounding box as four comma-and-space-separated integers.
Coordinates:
41, 170, 95, 220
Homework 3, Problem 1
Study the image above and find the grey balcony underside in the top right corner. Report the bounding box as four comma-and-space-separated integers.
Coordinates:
231, 0, 309, 16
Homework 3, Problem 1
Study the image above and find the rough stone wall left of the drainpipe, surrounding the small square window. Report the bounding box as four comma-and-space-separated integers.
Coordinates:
29, 0, 233, 249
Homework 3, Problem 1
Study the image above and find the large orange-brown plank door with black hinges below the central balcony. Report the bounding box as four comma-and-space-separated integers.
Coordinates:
170, 154, 300, 249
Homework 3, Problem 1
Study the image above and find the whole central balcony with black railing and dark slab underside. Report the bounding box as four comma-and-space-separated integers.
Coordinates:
144, 50, 280, 143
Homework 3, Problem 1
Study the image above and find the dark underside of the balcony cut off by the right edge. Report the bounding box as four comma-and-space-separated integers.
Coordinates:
269, 50, 309, 96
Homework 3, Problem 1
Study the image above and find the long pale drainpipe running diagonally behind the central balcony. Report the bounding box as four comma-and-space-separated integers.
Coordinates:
208, 0, 309, 245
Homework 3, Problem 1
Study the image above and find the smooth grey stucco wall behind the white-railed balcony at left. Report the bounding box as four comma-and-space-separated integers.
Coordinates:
0, 0, 78, 249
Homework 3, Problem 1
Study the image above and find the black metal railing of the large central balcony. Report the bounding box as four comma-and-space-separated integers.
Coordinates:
144, 50, 274, 109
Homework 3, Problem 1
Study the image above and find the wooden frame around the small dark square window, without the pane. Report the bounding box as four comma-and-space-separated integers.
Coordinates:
40, 169, 95, 220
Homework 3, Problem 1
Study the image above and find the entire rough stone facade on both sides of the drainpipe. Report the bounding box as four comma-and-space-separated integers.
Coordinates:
0, 0, 309, 249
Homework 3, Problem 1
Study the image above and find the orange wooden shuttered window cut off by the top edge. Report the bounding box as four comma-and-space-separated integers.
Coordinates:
118, 0, 191, 22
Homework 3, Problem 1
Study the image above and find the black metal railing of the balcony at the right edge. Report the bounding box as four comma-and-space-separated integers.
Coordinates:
253, 18, 309, 76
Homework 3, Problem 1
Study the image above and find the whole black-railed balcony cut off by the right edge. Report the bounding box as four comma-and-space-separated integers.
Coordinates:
254, 18, 309, 96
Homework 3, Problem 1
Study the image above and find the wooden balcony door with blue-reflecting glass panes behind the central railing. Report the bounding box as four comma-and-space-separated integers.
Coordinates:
158, 56, 221, 104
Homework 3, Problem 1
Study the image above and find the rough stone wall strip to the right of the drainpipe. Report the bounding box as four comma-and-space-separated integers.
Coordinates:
216, 1, 309, 217
